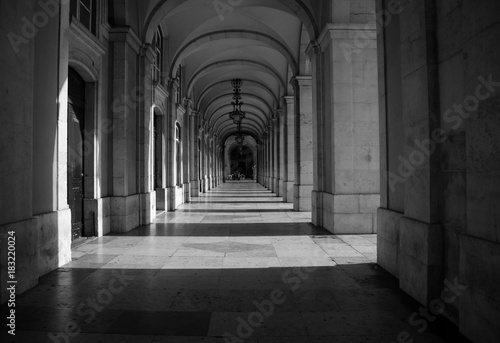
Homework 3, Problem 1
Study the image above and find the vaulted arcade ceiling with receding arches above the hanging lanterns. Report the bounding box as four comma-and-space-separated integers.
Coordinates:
131, 0, 318, 144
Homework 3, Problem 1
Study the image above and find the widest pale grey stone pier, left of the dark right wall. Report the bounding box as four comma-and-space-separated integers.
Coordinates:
309, 23, 380, 234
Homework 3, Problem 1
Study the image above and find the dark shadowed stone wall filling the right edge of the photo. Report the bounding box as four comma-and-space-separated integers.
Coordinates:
377, 0, 500, 342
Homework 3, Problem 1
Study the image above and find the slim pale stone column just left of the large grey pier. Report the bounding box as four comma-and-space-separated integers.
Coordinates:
292, 76, 313, 211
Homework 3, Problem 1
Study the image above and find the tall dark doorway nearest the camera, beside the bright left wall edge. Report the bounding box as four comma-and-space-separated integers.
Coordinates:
68, 68, 85, 241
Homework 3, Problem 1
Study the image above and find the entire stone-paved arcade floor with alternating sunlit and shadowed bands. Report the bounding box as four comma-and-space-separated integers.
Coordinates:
1, 182, 464, 343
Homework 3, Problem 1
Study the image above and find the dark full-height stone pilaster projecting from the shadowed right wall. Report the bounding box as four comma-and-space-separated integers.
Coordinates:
399, 0, 443, 305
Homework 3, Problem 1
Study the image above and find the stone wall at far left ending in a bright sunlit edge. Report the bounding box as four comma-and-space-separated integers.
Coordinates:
0, 1, 71, 303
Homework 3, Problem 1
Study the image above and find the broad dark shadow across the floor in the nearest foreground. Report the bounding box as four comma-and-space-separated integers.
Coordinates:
2, 264, 468, 343
